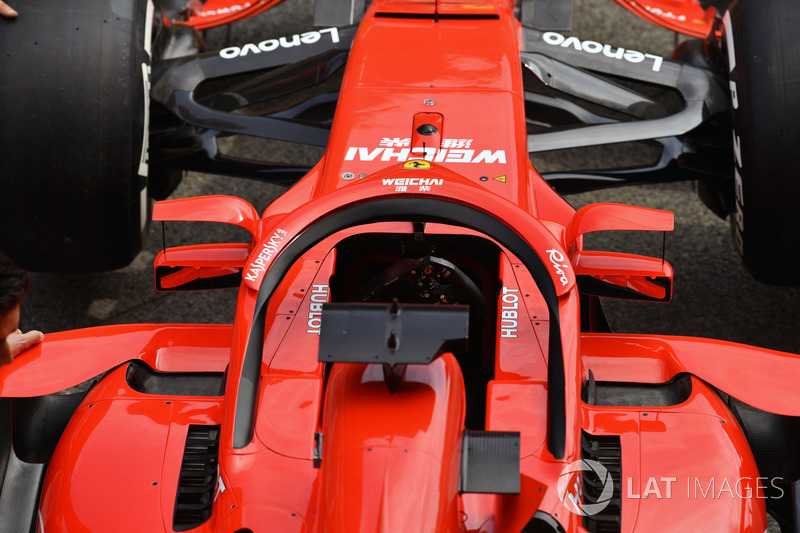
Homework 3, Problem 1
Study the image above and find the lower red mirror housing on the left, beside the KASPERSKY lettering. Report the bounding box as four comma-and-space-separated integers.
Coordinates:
154, 243, 250, 292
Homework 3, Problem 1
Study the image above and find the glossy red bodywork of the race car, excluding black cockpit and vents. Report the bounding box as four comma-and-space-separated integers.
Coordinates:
0, 0, 800, 533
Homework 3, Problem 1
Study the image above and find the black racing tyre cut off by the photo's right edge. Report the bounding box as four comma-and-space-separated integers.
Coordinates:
724, 0, 800, 285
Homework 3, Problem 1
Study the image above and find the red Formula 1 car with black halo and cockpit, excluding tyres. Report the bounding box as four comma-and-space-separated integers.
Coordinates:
0, 0, 800, 533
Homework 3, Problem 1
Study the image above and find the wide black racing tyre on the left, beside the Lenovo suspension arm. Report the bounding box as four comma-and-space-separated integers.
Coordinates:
0, 0, 153, 272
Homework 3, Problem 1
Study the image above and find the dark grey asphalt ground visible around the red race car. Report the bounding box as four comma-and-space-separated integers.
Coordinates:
21, 0, 800, 362
